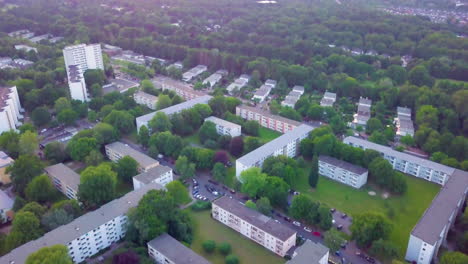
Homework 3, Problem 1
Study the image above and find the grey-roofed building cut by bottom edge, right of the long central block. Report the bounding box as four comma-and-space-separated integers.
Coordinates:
286, 239, 330, 264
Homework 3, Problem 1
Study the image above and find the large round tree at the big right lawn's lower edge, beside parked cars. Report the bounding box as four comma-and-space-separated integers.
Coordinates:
350, 212, 393, 247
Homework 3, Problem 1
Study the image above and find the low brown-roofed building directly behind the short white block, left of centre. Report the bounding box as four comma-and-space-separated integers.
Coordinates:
105, 141, 159, 173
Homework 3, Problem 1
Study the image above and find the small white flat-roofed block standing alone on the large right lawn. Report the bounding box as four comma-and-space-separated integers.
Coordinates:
319, 155, 368, 189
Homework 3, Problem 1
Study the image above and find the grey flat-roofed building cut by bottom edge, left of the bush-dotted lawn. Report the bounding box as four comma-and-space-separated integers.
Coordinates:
147, 233, 210, 264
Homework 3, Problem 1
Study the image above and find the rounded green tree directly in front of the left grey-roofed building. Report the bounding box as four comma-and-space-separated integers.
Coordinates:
25, 174, 55, 203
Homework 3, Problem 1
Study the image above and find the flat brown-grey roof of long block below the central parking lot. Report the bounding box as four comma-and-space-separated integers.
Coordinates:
213, 196, 296, 241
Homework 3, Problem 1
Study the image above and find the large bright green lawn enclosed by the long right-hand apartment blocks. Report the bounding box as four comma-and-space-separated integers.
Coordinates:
294, 167, 440, 256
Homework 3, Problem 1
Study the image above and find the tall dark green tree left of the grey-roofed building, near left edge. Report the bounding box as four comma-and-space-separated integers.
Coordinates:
8, 155, 44, 194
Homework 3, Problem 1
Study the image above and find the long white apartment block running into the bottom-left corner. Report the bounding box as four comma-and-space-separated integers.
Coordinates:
0, 183, 163, 264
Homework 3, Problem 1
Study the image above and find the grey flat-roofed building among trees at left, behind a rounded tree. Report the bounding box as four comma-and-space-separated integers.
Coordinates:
44, 163, 80, 200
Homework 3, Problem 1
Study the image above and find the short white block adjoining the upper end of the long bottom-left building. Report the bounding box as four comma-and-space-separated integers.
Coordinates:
133, 165, 174, 190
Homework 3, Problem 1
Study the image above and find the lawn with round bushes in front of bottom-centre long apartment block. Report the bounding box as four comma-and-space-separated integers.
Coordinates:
189, 210, 285, 264
